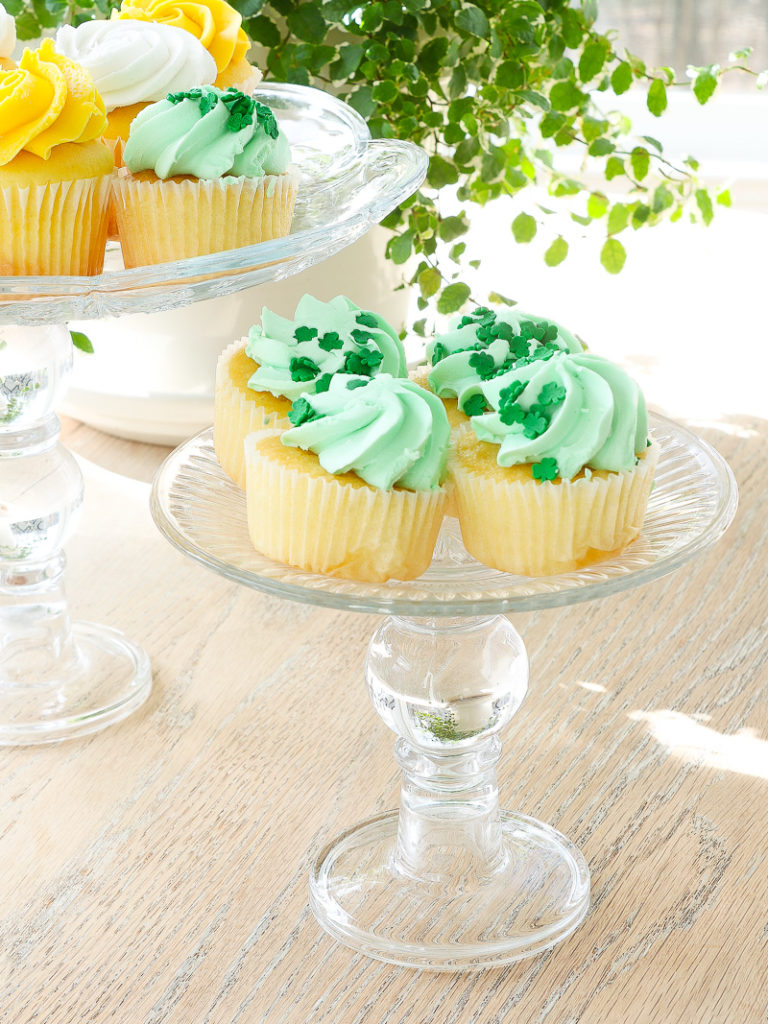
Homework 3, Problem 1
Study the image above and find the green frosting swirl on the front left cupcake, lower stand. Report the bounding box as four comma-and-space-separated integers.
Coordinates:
282, 374, 451, 490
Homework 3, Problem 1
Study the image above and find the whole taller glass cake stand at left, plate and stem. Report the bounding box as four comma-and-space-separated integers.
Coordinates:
0, 84, 427, 745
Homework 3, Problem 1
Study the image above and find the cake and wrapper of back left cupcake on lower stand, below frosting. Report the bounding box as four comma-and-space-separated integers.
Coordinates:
213, 340, 291, 490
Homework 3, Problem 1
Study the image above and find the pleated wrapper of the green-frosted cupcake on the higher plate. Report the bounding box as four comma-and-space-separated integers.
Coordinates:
114, 172, 298, 267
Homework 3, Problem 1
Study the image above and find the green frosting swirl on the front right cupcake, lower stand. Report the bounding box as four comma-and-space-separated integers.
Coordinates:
470, 352, 648, 479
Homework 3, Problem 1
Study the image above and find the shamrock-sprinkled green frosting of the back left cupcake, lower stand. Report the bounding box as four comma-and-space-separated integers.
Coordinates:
246, 295, 408, 401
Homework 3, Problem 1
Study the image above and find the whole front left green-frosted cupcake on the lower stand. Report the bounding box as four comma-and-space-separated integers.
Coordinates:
245, 374, 451, 582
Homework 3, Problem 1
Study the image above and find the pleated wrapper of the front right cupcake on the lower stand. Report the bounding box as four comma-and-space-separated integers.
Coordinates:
452, 444, 658, 575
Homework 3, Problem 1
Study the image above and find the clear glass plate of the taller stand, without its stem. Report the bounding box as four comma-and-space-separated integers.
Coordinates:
0, 83, 428, 324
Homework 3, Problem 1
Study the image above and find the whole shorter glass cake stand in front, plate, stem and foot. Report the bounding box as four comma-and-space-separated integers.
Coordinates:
152, 416, 737, 971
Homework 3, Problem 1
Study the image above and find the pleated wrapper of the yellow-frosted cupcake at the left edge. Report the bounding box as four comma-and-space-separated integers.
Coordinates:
0, 174, 112, 274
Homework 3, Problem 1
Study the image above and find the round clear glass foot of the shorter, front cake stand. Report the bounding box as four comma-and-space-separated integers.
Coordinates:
310, 811, 590, 971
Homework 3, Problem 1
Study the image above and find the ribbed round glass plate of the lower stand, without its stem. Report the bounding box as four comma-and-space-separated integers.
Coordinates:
152, 415, 737, 615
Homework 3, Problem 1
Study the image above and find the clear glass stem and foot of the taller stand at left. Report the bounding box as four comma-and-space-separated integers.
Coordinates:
0, 325, 152, 746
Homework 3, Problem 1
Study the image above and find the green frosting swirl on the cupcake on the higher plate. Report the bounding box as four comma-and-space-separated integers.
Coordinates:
123, 85, 291, 179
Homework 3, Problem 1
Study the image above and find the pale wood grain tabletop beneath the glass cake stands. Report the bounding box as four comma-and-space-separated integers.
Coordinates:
0, 409, 768, 1024
